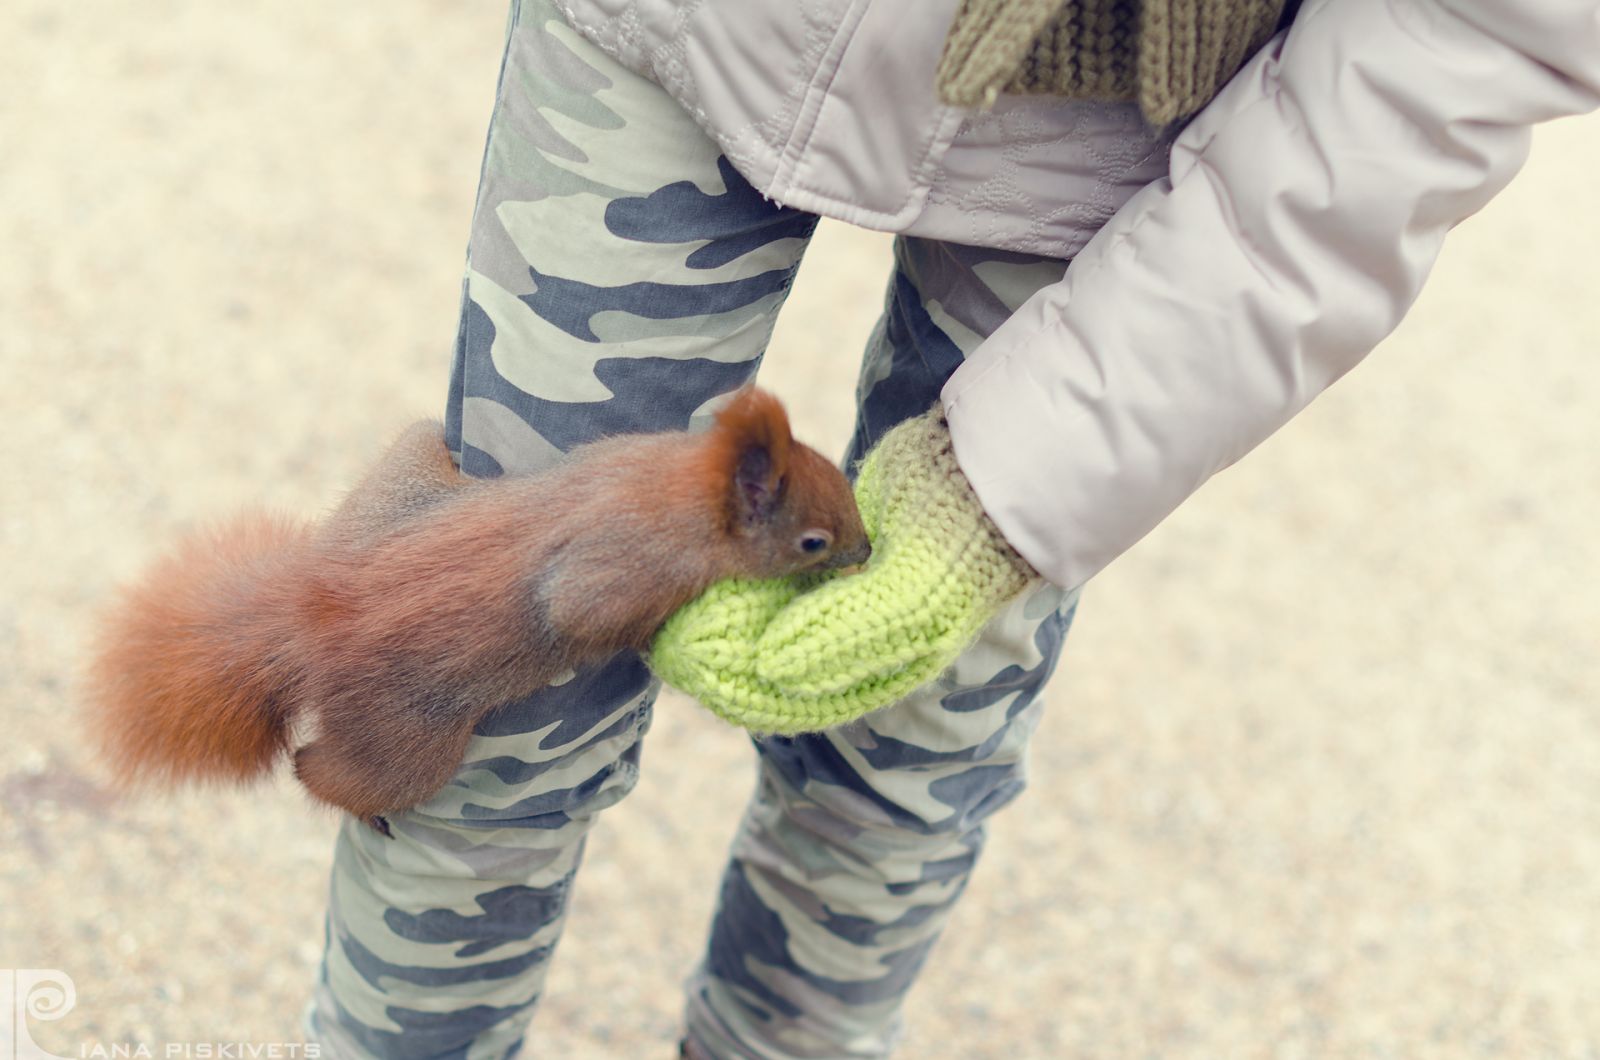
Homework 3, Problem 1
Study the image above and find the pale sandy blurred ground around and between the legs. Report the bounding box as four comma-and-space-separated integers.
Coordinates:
0, 0, 1600, 1060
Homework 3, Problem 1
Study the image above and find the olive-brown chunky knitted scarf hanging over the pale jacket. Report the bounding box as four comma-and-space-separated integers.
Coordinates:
936, 0, 1298, 125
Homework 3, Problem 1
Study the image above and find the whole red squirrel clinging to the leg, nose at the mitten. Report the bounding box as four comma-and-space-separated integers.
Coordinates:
86, 387, 869, 834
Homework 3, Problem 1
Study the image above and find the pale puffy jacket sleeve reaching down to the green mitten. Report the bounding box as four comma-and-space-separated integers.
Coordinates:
942, 0, 1600, 588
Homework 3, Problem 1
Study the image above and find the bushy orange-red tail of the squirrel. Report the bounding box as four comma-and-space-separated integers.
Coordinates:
86, 514, 310, 794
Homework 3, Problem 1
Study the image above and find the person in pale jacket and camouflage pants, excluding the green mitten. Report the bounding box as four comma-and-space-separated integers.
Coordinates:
312, 0, 1600, 1058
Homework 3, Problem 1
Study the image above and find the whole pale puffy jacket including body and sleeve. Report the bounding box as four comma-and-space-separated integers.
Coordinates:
560, 0, 1600, 586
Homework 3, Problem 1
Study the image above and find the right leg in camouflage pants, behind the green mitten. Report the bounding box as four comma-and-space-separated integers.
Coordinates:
688, 239, 1075, 1060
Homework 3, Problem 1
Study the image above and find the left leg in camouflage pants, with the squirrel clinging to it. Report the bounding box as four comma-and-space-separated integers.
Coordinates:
310, 0, 814, 1060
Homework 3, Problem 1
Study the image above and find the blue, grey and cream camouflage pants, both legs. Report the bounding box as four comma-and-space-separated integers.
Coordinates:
309, 0, 1074, 1058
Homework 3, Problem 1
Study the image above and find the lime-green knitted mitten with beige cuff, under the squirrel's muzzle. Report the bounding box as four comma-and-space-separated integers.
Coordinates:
650, 408, 1037, 733
